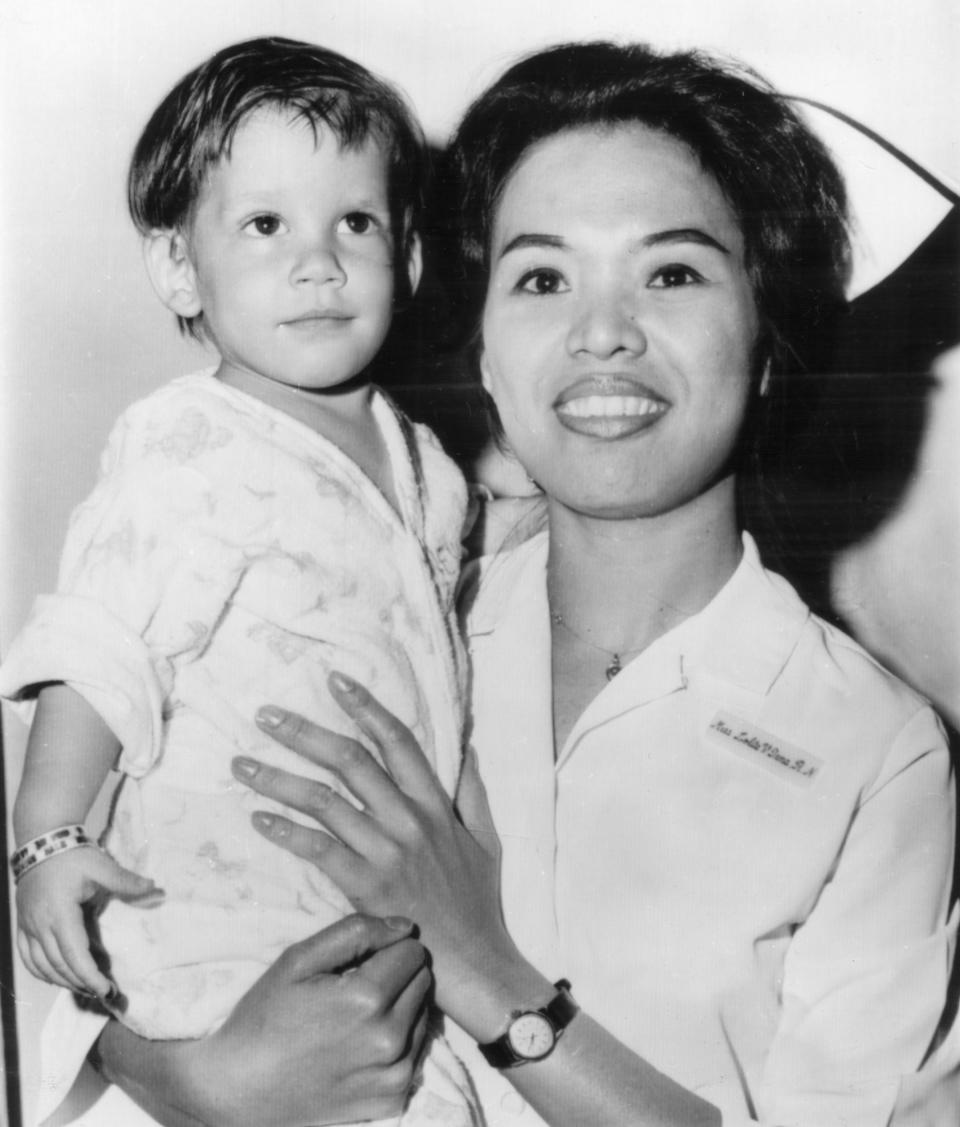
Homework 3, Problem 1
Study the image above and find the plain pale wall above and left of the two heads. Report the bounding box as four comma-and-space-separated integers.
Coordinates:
0, 0, 960, 1121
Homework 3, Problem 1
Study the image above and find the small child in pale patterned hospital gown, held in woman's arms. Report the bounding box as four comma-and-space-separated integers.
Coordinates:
0, 39, 474, 1124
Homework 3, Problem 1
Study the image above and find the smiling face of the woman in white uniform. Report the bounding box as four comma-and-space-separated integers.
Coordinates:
481, 124, 758, 518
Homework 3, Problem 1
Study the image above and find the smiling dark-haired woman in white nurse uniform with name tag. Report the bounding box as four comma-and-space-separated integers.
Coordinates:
87, 44, 955, 1127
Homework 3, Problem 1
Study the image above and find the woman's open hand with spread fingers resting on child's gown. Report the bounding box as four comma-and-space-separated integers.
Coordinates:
233, 674, 516, 1020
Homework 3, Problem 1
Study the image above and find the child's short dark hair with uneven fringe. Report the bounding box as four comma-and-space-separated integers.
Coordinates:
127, 37, 425, 336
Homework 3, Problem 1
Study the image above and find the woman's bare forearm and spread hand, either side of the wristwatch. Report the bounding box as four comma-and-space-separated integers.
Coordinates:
240, 678, 720, 1127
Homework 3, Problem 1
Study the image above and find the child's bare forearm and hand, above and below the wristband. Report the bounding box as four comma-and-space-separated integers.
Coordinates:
14, 684, 154, 995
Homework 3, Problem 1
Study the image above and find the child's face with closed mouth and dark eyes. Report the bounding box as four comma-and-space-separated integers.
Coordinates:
188, 109, 394, 394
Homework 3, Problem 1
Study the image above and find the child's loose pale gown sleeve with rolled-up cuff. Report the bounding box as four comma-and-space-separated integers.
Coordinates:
0, 405, 251, 775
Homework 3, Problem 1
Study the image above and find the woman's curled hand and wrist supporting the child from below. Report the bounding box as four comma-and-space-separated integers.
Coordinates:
98, 915, 430, 1127
